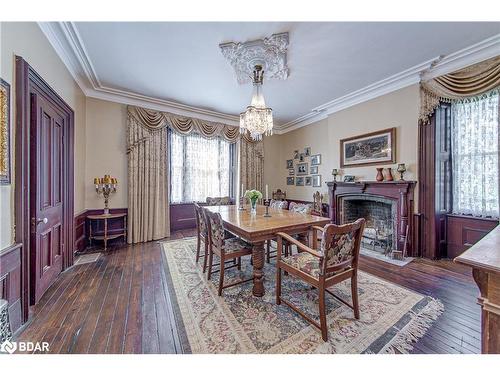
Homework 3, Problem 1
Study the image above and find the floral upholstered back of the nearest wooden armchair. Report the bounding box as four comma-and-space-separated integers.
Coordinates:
320, 218, 365, 275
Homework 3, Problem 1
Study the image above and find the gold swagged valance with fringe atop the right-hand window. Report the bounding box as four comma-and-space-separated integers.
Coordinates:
419, 56, 500, 124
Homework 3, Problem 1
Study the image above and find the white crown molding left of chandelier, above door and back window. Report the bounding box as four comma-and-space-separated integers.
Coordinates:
38, 22, 239, 126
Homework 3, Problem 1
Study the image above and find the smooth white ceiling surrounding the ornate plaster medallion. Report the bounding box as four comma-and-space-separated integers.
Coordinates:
56, 22, 500, 129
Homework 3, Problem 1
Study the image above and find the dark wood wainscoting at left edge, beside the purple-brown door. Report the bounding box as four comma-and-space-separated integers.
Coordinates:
0, 243, 24, 332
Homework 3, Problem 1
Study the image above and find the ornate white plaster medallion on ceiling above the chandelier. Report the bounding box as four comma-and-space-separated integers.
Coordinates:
219, 32, 288, 85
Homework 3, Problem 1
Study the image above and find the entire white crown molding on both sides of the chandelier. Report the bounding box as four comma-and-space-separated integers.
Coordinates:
38, 22, 500, 134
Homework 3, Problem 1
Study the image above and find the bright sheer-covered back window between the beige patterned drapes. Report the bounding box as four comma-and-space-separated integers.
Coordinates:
169, 131, 236, 203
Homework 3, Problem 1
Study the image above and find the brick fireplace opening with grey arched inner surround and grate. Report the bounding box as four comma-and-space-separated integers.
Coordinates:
339, 195, 397, 255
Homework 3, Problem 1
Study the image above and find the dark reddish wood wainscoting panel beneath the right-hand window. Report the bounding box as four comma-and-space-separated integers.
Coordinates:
446, 215, 498, 259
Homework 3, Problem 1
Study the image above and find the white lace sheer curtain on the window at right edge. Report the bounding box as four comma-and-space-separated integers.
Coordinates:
452, 92, 500, 218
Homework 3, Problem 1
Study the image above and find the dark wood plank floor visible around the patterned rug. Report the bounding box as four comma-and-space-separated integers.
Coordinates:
18, 231, 480, 353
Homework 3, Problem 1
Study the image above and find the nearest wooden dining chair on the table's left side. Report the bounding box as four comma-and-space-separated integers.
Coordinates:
205, 210, 253, 296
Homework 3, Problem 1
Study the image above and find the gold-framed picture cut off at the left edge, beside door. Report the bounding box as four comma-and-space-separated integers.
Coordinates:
0, 78, 10, 185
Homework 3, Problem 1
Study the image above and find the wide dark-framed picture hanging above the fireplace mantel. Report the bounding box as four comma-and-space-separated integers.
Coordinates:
340, 128, 396, 168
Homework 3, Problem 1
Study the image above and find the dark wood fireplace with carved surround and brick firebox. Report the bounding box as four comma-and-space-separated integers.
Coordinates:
327, 181, 418, 257
